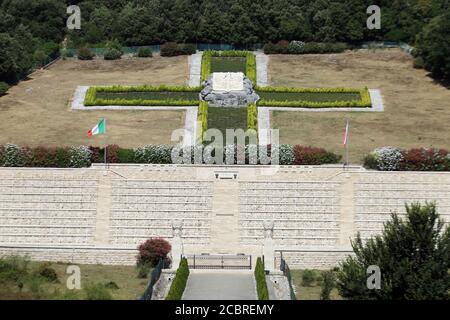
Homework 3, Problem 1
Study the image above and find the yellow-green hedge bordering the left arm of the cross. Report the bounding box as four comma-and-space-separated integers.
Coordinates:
84, 85, 202, 107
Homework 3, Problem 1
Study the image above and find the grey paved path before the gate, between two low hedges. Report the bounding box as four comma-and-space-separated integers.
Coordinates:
183, 270, 257, 300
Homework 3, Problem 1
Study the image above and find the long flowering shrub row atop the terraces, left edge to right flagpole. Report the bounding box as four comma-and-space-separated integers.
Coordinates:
0, 144, 341, 168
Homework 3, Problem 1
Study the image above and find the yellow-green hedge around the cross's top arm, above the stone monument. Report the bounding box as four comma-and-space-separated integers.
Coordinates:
201, 50, 256, 84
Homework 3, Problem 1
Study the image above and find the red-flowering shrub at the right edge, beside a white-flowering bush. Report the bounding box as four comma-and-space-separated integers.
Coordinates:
400, 148, 450, 171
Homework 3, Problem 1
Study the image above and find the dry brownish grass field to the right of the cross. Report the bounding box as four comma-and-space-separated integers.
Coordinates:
269, 49, 450, 163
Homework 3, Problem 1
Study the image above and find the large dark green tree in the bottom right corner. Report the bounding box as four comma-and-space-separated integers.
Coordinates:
337, 203, 450, 300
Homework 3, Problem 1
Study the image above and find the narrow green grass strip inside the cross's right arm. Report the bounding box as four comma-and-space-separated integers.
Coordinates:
257, 91, 361, 102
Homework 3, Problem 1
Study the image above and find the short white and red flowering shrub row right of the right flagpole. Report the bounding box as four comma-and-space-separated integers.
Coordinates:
364, 147, 450, 171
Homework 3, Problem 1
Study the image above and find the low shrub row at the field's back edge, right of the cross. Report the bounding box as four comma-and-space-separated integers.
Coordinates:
264, 41, 348, 54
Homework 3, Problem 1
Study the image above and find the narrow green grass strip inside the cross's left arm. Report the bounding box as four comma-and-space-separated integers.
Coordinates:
96, 91, 199, 100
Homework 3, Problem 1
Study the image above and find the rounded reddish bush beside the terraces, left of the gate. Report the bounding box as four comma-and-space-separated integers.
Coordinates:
137, 238, 172, 267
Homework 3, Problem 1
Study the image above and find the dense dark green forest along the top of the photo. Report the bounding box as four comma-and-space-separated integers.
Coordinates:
0, 0, 450, 84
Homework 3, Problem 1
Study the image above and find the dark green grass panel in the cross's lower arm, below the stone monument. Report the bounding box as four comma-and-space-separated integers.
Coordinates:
208, 106, 247, 138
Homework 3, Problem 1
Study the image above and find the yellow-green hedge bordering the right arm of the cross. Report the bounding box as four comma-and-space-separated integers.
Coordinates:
256, 87, 372, 108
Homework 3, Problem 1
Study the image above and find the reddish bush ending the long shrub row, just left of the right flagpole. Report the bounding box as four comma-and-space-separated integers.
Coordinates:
293, 145, 342, 165
